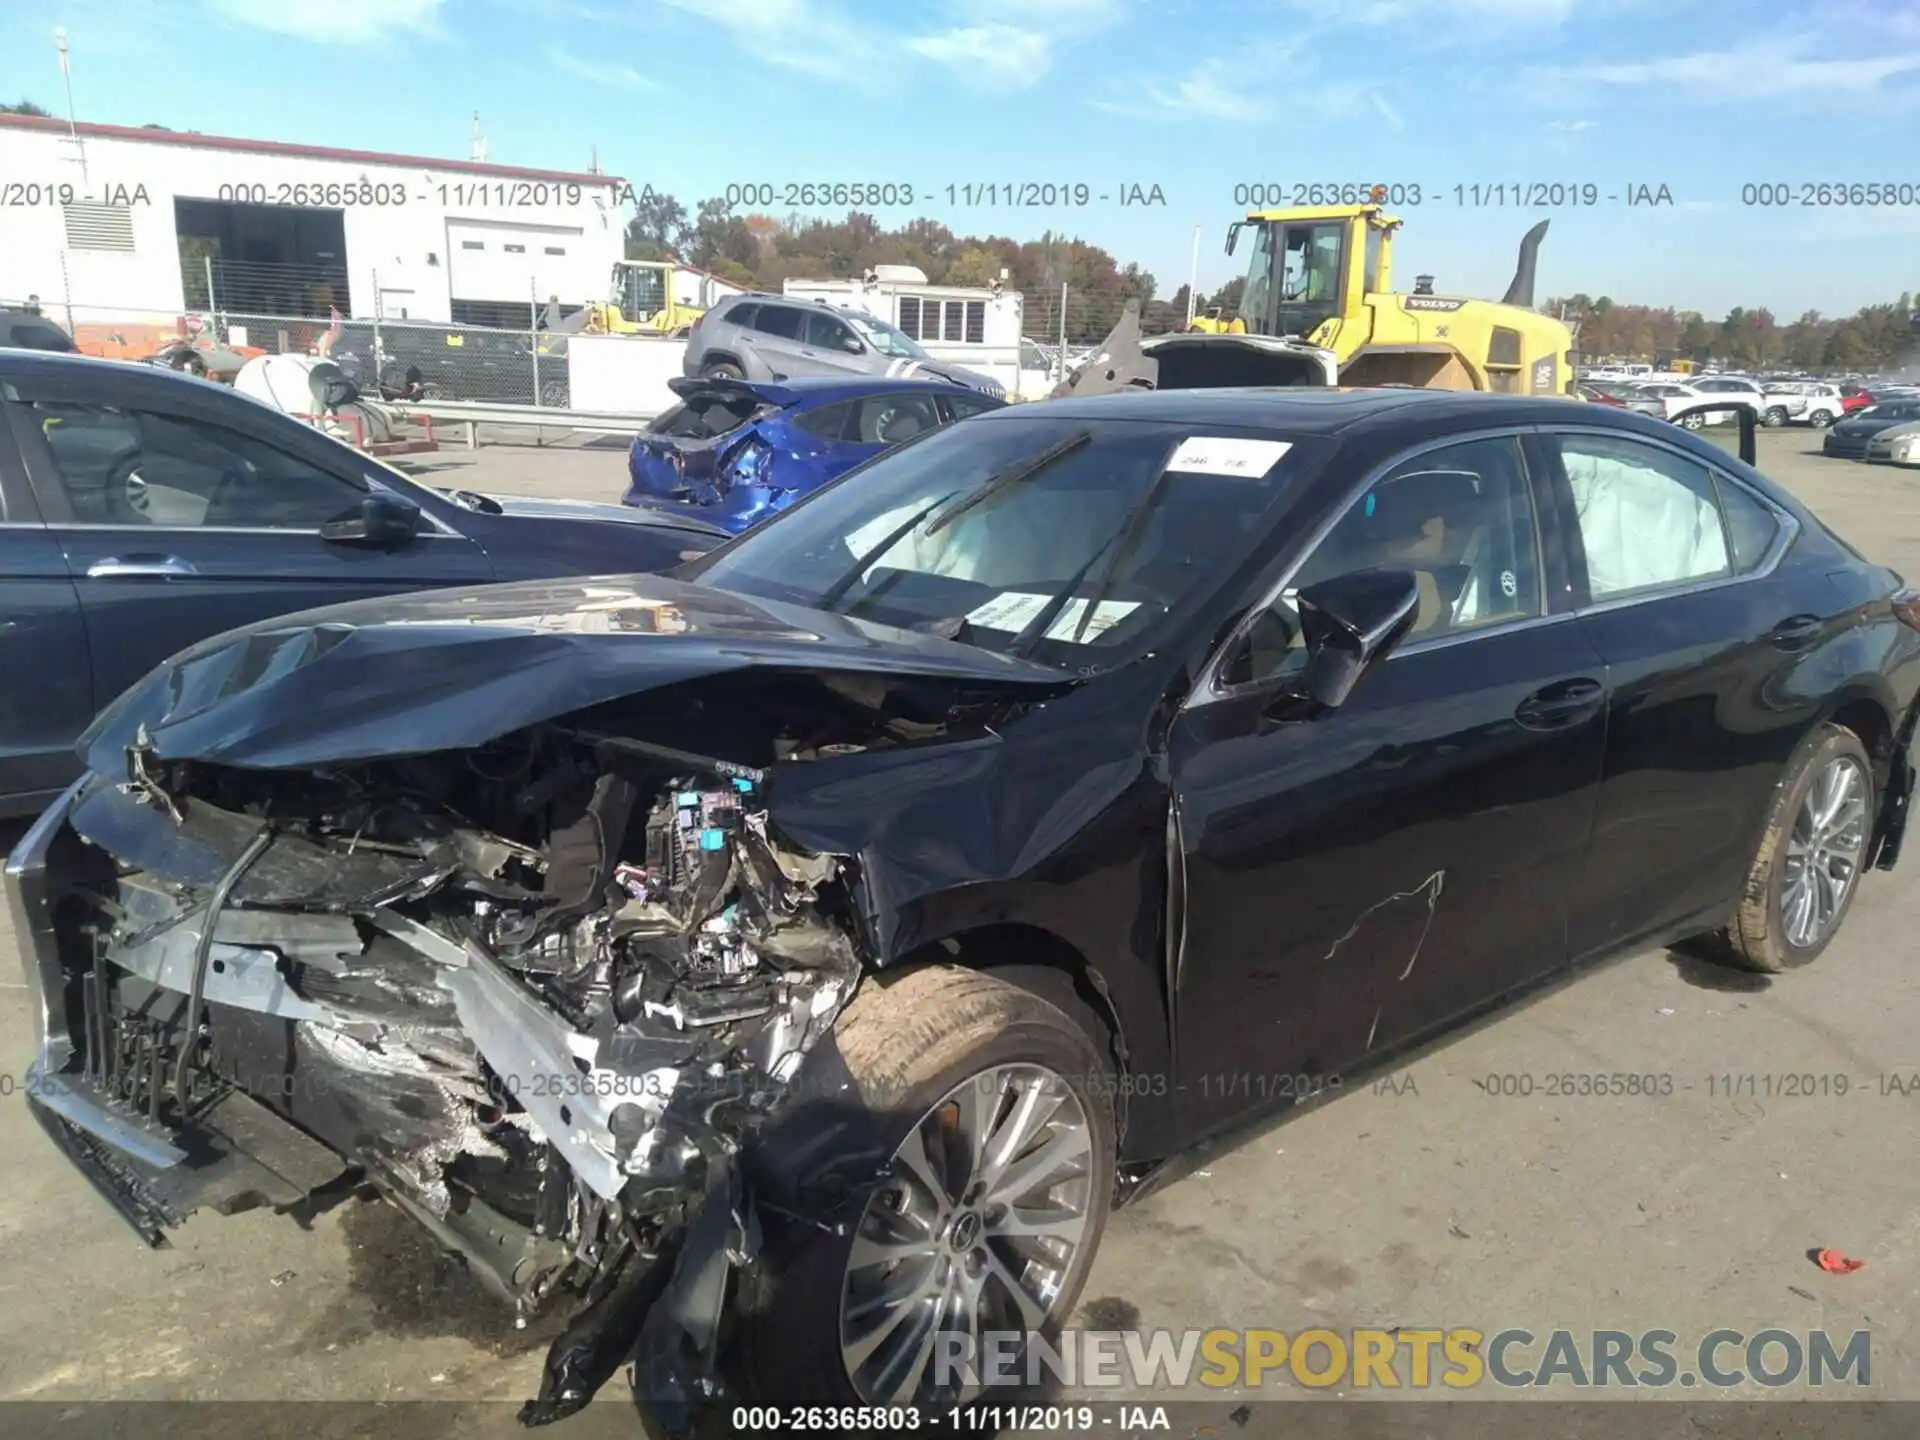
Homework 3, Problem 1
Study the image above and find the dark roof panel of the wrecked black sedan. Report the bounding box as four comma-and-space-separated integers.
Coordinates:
981, 386, 1635, 436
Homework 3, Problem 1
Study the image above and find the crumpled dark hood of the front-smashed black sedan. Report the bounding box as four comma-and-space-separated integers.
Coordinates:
79, 574, 1073, 774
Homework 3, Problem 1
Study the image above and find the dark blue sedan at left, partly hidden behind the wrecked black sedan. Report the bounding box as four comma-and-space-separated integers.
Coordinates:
0, 349, 724, 814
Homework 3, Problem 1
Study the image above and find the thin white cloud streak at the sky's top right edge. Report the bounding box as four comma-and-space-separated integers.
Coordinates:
1524, 36, 1920, 102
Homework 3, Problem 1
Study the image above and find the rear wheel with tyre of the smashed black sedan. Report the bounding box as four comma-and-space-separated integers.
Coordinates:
1726, 724, 1878, 973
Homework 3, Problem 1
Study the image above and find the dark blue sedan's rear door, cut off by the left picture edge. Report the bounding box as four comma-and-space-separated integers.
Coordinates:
0, 415, 94, 816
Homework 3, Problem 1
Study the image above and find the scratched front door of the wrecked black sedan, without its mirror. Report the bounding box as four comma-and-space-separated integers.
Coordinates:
1169, 436, 1605, 1129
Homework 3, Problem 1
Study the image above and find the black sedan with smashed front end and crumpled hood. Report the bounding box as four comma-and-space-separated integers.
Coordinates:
8, 390, 1920, 1434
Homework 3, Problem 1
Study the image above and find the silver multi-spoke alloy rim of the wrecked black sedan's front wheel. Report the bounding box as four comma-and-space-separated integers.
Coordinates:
841, 1064, 1094, 1405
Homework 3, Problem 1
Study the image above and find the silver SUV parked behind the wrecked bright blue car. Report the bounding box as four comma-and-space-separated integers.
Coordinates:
682, 294, 1006, 399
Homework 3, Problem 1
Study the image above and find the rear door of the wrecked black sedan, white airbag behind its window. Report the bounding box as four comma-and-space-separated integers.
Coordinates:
1542, 430, 1820, 956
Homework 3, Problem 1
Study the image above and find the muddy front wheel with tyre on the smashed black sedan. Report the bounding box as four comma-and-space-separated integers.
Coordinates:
737, 966, 1116, 1409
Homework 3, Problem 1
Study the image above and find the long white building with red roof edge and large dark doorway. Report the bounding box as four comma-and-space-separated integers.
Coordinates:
0, 115, 632, 326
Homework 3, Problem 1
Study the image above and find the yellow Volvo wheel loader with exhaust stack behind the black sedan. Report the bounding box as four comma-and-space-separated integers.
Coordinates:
1054, 205, 1578, 397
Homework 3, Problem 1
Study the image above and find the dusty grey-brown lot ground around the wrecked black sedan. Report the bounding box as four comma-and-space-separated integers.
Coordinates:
0, 422, 1920, 1440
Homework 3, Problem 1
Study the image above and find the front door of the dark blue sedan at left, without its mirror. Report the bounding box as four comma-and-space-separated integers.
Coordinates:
10, 367, 493, 718
